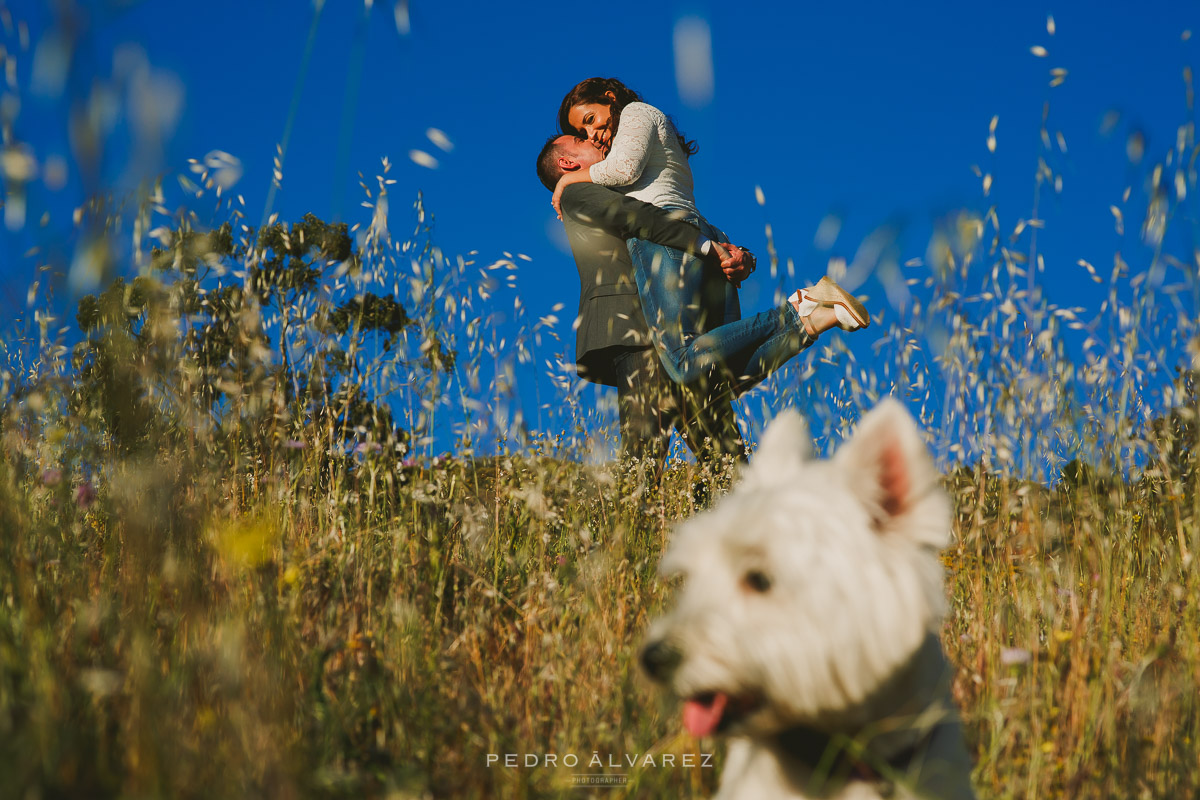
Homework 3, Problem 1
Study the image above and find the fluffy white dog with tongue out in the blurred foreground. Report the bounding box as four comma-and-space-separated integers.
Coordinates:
642, 401, 974, 800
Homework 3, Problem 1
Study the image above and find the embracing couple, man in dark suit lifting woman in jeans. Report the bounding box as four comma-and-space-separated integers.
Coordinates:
538, 78, 870, 461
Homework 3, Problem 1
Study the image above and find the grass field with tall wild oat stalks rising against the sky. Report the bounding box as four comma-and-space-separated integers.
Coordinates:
0, 9, 1200, 800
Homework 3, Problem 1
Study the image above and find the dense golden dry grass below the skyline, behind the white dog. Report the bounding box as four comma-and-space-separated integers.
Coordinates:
0, 391, 1200, 798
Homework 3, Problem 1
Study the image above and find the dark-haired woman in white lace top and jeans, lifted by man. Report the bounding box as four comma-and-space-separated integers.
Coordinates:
551, 78, 870, 384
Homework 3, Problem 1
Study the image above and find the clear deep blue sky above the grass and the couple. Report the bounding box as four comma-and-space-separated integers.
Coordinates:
0, 0, 1198, 455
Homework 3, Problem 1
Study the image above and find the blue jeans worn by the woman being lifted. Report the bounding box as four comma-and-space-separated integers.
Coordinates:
629, 216, 816, 389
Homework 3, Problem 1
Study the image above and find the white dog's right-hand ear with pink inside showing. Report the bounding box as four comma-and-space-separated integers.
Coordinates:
833, 398, 950, 548
